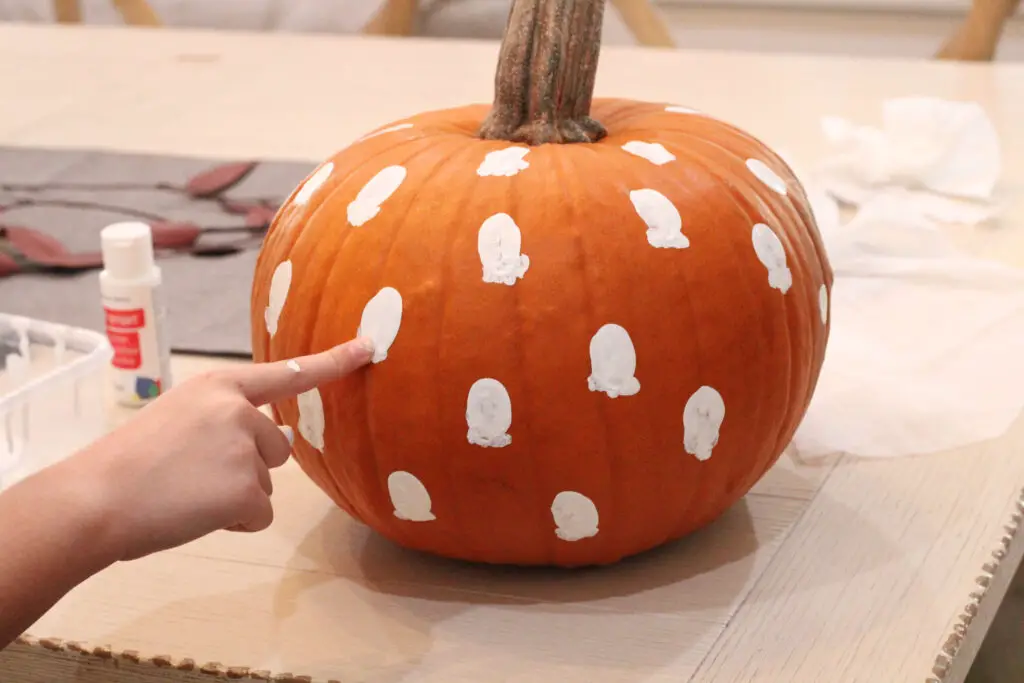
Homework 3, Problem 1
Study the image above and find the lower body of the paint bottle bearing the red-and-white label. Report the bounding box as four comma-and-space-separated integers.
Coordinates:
103, 288, 170, 403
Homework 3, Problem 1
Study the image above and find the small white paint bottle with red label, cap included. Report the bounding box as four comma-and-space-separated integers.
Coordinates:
99, 222, 171, 407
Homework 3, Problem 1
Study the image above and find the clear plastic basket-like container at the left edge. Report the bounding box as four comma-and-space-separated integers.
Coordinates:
0, 313, 113, 489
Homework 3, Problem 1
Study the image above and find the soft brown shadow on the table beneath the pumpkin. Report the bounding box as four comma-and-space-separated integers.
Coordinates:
297, 499, 765, 612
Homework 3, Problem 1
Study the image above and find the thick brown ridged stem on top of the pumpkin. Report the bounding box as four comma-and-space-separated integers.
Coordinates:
478, 0, 607, 145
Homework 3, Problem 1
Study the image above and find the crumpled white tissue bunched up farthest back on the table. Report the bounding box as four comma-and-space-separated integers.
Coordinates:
815, 97, 1002, 224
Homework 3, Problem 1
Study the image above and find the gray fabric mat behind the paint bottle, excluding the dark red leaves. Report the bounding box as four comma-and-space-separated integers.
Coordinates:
0, 147, 315, 356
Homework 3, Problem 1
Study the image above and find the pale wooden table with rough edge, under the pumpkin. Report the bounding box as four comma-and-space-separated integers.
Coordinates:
0, 21, 1024, 683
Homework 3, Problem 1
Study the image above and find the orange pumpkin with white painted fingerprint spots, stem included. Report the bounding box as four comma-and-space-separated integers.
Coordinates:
252, 0, 833, 566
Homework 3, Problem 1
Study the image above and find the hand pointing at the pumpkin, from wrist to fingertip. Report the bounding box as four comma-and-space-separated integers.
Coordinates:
72, 340, 373, 560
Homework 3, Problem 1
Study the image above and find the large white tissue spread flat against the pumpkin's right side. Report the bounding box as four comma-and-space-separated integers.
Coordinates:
793, 192, 1024, 458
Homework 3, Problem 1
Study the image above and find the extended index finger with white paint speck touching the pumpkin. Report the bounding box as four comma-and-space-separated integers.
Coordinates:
230, 338, 374, 407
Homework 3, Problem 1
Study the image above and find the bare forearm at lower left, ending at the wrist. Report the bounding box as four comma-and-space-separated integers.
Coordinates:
0, 457, 117, 649
